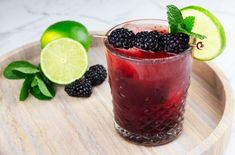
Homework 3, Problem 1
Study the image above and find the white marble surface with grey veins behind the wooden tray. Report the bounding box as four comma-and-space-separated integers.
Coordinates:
0, 0, 235, 155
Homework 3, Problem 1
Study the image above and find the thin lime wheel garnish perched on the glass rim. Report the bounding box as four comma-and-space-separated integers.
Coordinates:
181, 6, 226, 61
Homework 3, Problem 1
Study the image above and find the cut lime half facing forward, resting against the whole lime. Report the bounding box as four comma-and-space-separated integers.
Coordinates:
40, 38, 88, 84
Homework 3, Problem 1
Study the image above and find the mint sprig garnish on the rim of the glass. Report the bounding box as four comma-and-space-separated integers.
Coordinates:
167, 5, 206, 39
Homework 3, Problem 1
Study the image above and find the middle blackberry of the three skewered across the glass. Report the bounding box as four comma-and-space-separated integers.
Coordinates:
133, 31, 163, 52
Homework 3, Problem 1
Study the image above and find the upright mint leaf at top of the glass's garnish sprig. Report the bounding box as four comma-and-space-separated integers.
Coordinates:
167, 5, 183, 33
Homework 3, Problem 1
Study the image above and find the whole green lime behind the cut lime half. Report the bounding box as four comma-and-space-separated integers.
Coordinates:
41, 21, 91, 51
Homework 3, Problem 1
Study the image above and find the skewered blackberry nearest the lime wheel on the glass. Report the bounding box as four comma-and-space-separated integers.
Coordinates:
162, 33, 189, 53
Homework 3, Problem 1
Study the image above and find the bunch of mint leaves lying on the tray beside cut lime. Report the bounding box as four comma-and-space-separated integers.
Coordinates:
3, 61, 55, 101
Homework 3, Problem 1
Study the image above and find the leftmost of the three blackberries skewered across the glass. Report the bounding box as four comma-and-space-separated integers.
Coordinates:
108, 28, 135, 49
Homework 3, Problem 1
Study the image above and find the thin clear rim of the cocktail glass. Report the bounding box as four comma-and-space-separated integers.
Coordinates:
103, 19, 192, 63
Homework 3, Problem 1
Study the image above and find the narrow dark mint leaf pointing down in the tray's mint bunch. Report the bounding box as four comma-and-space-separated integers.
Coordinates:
19, 77, 33, 101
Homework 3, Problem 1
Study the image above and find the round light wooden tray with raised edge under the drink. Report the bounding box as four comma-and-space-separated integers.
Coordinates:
0, 38, 234, 155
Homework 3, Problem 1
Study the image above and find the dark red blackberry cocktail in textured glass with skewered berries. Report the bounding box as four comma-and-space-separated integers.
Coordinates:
105, 20, 191, 145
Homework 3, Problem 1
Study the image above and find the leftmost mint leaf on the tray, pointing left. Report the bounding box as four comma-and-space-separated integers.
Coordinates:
3, 61, 39, 79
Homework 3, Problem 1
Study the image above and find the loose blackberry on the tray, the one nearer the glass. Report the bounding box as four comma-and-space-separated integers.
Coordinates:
84, 64, 107, 86
